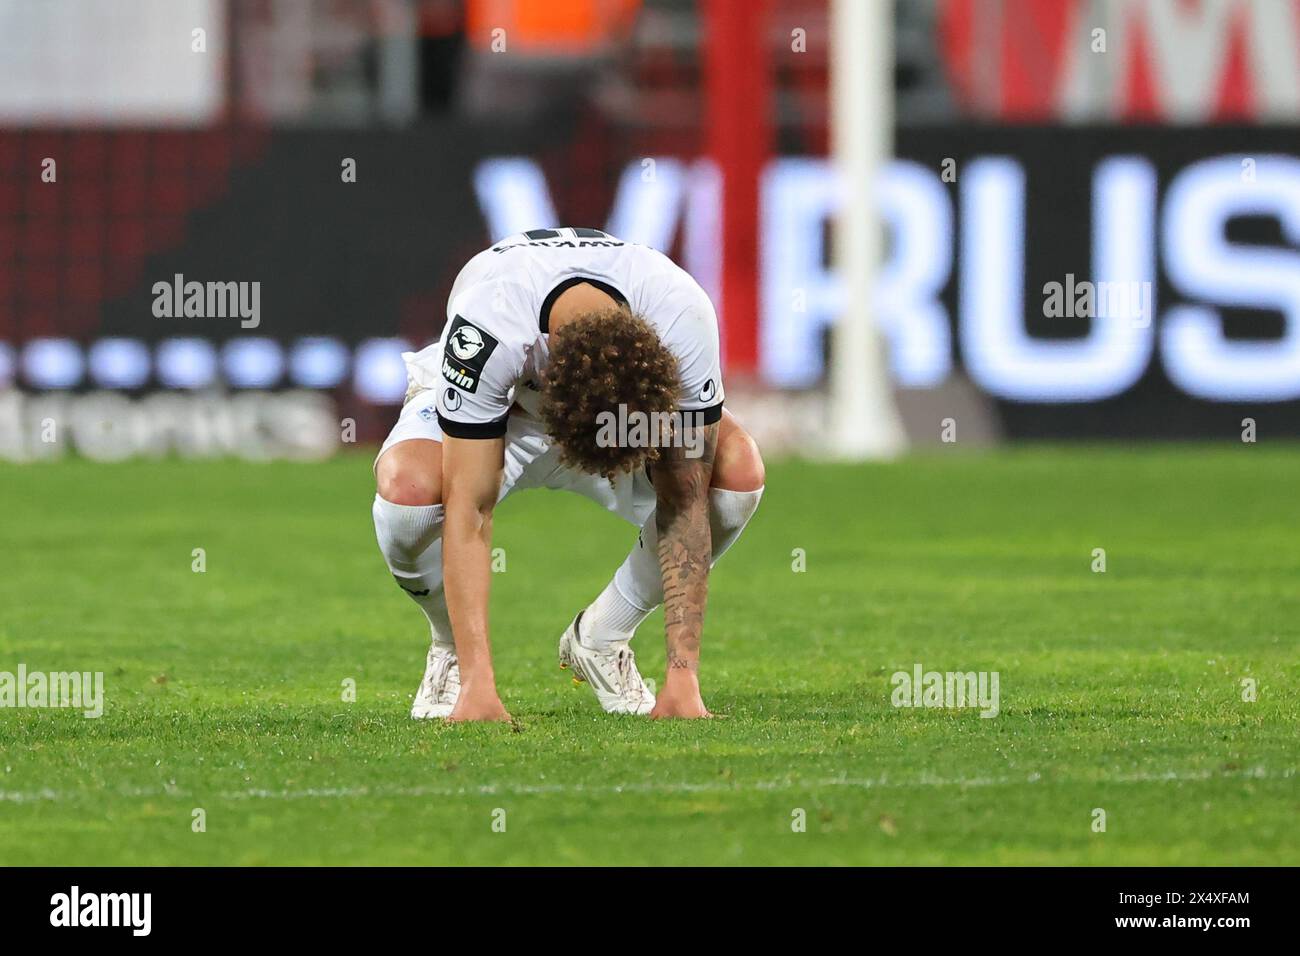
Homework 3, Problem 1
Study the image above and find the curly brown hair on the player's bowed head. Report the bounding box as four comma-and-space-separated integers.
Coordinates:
541, 307, 677, 480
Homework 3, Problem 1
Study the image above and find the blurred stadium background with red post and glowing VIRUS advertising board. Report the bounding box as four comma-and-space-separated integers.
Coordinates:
0, 0, 1300, 460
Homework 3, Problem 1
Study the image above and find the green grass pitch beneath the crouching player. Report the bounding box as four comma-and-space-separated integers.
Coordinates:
0, 445, 1300, 865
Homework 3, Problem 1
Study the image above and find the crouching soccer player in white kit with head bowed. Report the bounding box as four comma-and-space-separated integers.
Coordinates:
373, 228, 763, 721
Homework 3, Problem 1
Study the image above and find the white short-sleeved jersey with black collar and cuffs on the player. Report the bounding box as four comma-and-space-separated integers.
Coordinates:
408, 226, 723, 438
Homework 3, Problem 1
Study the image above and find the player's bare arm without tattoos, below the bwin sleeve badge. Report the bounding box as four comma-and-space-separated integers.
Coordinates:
442, 436, 510, 721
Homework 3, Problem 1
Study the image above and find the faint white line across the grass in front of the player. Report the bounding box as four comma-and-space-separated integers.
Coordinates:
0, 767, 1296, 804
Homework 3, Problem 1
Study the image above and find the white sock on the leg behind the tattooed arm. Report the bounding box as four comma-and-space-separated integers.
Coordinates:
582, 488, 763, 644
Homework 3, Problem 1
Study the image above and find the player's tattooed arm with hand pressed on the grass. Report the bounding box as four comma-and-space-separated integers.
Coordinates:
650, 423, 718, 717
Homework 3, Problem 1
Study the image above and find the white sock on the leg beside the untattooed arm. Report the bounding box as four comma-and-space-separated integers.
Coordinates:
371, 494, 456, 653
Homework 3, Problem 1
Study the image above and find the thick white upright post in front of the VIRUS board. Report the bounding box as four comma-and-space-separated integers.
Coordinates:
827, 0, 906, 460
